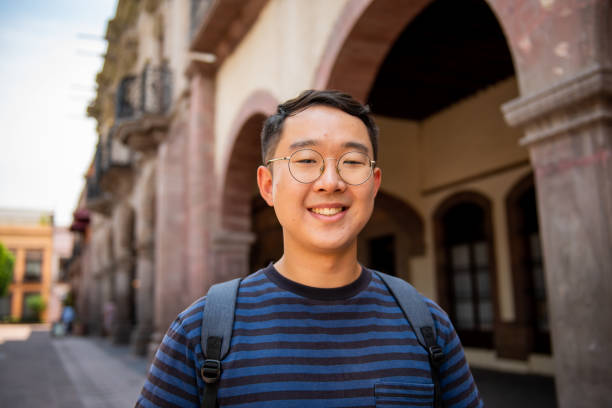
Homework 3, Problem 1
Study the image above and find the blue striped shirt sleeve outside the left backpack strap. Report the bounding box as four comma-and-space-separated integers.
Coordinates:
136, 316, 200, 408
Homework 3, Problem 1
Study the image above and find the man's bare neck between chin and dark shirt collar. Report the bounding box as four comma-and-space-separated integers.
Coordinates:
274, 242, 361, 288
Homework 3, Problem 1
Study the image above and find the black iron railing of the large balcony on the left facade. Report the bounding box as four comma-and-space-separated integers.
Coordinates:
115, 64, 172, 121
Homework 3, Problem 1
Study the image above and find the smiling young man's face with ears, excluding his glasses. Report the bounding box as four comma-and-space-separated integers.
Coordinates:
257, 106, 381, 253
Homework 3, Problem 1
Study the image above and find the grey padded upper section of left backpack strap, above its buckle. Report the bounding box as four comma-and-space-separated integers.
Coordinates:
200, 278, 242, 360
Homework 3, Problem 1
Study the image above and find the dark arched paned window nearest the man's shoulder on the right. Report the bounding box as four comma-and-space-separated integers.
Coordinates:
433, 191, 499, 348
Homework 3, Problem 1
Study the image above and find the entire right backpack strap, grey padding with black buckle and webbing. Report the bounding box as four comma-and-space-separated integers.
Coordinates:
374, 271, 445, 408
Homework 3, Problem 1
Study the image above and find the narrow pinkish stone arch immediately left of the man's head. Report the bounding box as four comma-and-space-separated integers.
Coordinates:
219, 90, 278, 232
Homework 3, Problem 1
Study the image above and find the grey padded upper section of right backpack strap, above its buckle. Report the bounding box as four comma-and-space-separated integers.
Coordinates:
374, 271, 437, 348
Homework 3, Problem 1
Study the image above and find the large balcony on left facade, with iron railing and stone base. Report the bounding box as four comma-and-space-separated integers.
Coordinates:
115, 64, 172, 151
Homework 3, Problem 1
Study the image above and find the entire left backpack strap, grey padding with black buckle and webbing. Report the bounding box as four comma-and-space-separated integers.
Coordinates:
200, 278, 242, 408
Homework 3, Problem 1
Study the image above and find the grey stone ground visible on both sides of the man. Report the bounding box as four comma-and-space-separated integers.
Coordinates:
0, 324, 556, 408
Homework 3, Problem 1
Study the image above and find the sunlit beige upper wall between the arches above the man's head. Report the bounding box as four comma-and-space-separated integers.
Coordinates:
215, 0, 347, 174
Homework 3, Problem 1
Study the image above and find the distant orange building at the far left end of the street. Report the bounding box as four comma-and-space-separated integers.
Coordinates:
0, 209, 53, 321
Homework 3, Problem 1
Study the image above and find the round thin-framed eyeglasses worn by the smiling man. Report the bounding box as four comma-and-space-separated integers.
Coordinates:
266, 149, 376, 186
